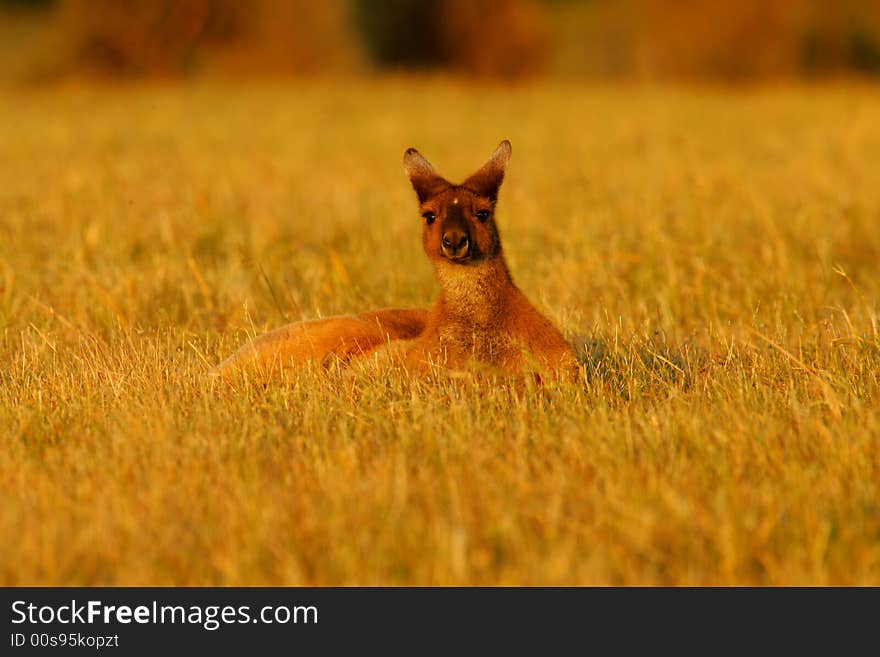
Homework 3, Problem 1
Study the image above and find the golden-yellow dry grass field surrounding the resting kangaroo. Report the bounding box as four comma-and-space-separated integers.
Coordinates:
0, 80, 880, 585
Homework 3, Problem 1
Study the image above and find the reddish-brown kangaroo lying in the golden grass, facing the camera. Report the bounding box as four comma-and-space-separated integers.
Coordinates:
212, 140, 577, 380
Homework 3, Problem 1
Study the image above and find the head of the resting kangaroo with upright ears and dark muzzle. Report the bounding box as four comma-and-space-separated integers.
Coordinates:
403, 140, 510, 266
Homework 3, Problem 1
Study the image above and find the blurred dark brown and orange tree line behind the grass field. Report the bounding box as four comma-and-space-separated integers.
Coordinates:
0, 0, 880, 80
